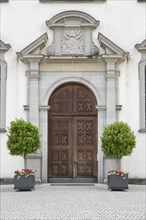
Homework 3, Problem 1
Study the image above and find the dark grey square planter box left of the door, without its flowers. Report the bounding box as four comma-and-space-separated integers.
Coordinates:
14, 175, 35, 190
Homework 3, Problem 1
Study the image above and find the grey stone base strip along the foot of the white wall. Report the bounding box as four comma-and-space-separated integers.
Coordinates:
0, 178, 146, 185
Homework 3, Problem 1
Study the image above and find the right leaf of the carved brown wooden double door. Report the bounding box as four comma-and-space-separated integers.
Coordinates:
74, 84, 97, 178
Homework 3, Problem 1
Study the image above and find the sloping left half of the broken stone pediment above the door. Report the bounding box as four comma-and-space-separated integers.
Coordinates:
17, 33, 48, 57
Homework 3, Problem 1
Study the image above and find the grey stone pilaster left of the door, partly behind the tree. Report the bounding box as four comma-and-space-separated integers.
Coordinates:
20, 55, 43, 182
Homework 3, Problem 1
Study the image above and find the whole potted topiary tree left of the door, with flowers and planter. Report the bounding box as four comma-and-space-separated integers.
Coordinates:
7, 119, 40, 190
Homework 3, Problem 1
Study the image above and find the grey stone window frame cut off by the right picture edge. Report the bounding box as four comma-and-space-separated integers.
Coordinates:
135, 39, 146, 132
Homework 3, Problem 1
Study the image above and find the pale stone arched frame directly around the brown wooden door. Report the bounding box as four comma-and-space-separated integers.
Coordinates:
39, 77, 106, 183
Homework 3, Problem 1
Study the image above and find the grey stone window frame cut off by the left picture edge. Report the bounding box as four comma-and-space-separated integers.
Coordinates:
0, 40, 11, 132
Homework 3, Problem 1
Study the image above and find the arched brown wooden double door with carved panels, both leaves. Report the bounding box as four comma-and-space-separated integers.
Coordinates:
48, 83, 97, 182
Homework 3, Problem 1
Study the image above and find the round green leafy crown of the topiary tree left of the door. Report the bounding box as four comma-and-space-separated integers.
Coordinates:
7, 119, 40, 157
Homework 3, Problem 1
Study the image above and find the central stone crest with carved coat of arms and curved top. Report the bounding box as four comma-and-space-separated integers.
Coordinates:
46, 11, 99, 57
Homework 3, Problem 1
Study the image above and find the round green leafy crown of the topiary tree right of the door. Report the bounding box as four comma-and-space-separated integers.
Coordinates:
101, 121, 136, 157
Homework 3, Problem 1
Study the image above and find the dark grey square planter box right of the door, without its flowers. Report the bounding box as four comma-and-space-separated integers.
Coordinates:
107, 174, 129, 190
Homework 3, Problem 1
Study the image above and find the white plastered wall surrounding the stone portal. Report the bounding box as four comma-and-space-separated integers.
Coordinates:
0, 0, 146, 178
